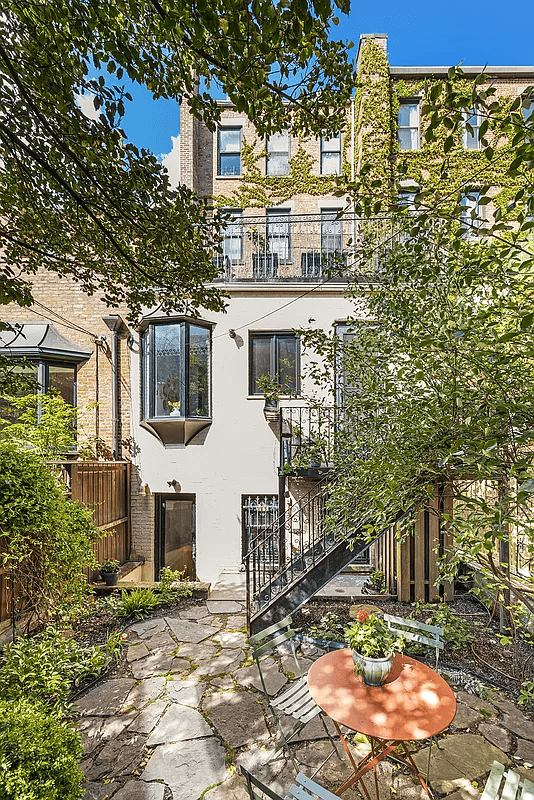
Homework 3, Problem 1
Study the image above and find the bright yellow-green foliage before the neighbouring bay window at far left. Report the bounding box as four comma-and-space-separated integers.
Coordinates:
0, 393, 78, 458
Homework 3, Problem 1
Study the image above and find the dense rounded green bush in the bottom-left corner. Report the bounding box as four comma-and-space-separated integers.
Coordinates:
0, 699, 84, 800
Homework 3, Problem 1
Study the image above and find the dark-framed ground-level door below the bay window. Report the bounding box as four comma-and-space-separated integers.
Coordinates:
155, 494, 196, 580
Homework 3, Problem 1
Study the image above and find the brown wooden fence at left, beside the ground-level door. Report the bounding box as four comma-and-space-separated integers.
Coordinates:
0, 461, 130, 625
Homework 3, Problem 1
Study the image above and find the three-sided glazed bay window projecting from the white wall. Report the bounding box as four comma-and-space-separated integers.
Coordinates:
142, 320, 211, 419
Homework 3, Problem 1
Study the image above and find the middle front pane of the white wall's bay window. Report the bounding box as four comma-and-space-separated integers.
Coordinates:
153, 325, 185, 417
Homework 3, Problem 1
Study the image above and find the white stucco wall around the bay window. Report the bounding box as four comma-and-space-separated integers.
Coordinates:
131, 287, 351, 581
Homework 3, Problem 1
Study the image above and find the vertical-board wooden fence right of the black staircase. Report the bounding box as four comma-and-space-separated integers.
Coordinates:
373, 488, 454, 603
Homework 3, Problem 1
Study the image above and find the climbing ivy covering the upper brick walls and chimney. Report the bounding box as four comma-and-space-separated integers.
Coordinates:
214, 39, 525, 217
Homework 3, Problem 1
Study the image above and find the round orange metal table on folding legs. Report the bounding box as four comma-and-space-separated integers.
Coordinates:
308, 648, 456, 798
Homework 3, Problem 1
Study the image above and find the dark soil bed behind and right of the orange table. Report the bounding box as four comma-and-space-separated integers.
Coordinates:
293, 594, 534, 695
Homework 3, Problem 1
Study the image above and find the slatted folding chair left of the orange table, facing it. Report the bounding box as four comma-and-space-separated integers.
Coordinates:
249, 617, 340, 777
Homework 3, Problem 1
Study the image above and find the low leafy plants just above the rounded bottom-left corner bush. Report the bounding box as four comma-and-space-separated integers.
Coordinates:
0, 626, 120, 710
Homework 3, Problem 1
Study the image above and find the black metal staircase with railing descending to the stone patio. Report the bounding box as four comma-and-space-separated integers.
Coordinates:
244, 475, 396, 633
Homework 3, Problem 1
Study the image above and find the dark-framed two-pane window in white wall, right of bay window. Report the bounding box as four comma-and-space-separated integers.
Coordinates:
249, 333, 300, 395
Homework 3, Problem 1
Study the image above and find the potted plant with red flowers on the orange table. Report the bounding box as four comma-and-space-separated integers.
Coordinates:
345, 609, 404, 686
